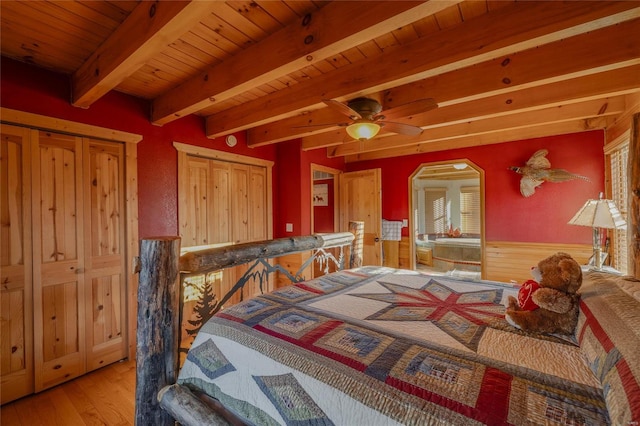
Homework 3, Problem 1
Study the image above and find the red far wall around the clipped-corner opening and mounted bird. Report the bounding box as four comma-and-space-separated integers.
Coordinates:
347, 131, 604, 244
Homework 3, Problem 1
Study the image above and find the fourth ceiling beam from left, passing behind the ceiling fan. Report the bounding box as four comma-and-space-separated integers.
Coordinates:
258, 19, 640, 149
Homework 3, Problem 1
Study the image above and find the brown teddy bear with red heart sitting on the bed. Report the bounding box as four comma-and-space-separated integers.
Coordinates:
505, 252, 582, 334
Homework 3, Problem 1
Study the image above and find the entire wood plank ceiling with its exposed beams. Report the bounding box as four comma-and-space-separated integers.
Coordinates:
0, 0, 640, 161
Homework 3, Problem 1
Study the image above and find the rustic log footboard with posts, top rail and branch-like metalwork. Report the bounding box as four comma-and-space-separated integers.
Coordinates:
135, 222, 364, 425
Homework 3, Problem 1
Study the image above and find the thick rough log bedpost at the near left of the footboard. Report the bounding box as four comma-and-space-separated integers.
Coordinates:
135, 237, 181, 426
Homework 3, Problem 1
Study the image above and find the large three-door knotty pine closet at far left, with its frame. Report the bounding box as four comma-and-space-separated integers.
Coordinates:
1, 115, 137, 402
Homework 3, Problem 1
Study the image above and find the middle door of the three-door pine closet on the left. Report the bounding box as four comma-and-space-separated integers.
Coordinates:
31, 131, 86, 392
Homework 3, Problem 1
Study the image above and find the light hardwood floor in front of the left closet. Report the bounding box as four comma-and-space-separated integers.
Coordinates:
0, 361, 136, 426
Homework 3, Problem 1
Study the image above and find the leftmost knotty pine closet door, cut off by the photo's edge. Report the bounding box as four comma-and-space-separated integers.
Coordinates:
0, 124, 33, 404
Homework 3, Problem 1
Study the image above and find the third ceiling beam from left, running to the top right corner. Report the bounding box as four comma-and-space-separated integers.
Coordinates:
211, 2, 640, 141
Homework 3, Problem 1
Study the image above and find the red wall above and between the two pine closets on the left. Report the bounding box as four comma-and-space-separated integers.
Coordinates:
0, 58, 277, 238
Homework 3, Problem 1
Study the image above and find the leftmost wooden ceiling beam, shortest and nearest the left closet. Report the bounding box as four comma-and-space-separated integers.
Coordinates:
71, 1, 211, 108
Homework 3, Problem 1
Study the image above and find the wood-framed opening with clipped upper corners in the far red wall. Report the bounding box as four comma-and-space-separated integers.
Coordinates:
409, 159, 484, 279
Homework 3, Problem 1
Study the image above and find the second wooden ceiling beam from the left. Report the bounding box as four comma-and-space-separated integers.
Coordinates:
152, 0, 461, 124
